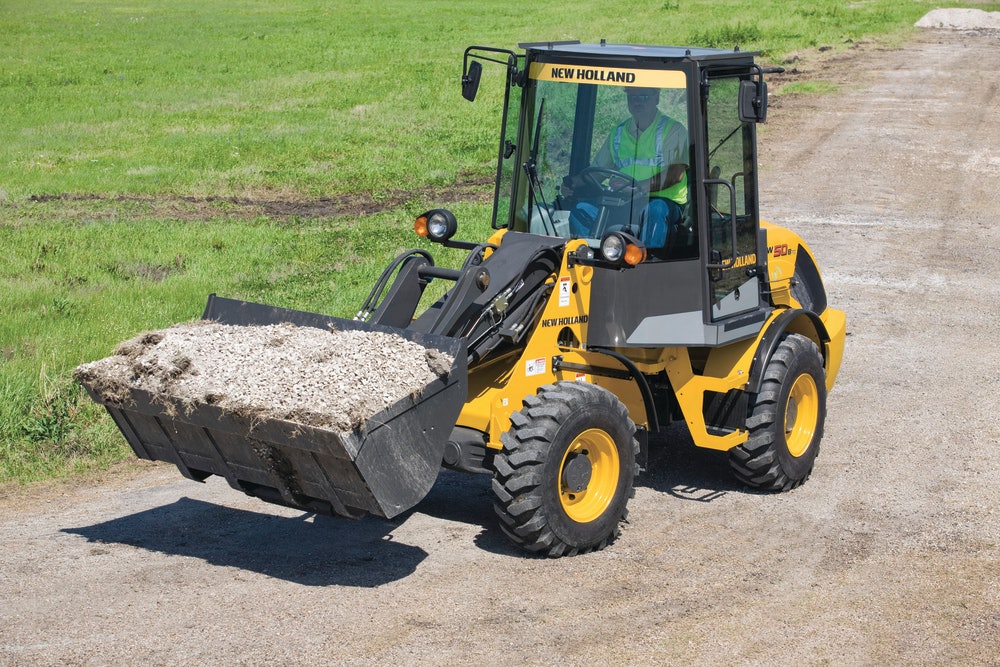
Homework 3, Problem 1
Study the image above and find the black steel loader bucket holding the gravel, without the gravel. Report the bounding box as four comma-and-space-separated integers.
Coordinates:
81, 295, 468, 518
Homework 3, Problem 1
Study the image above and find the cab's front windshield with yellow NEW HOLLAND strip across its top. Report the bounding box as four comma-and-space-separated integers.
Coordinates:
514, 63, 693, 254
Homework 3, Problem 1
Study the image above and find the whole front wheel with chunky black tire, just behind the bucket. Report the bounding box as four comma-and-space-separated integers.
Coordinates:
493, 382, 639, 557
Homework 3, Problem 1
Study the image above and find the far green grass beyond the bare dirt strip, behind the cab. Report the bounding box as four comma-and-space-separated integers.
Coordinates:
0, 0, 984, 201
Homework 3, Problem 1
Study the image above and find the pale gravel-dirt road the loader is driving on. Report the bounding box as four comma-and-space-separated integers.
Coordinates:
0, 32, 1000, 665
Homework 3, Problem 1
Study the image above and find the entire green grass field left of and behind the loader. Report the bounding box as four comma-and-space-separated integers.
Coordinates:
0, 0, 990, 483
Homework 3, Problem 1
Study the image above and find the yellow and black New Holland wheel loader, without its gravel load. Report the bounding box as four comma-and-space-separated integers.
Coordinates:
78, 41, 845, 557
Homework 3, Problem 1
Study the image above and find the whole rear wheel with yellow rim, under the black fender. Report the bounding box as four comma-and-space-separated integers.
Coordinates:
729, 334, 826, 491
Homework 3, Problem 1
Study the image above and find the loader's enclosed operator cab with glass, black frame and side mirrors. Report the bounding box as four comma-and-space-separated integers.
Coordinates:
463, 42, 769, 347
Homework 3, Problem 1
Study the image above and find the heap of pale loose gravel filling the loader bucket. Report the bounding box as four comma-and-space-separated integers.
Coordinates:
74, 321, 453, 431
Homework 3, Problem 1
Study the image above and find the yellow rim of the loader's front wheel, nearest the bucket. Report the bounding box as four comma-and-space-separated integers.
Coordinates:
559, 428, 620, 523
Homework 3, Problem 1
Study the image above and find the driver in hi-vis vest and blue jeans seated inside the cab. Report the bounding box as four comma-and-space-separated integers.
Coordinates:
562, 88, 689, 248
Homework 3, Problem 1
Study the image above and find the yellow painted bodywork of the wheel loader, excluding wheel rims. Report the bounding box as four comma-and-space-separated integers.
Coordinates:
457, 223, 845, 451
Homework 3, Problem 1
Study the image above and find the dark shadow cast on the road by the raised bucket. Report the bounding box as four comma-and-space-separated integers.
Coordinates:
62, 498, 427, 588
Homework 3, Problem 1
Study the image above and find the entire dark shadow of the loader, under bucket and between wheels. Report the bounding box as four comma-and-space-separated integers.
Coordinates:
63, 425, 754, 576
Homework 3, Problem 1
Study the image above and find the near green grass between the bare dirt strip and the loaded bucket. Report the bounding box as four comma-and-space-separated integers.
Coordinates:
0, 201, 488, 481
